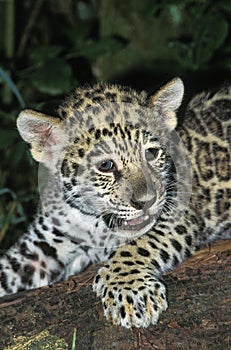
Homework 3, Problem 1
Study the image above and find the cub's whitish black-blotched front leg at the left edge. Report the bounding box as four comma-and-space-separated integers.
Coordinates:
0, 222, 90, 297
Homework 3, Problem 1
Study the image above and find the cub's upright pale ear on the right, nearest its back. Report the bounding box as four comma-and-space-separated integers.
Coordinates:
150, 78, 184, 130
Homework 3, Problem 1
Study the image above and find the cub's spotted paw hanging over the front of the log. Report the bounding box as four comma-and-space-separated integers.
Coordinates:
93, 267, 168, 328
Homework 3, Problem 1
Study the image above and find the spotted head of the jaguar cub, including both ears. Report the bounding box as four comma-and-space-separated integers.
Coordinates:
17, 78, 188, 237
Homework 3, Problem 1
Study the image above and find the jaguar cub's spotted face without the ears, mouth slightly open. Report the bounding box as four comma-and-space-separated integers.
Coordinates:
60, 105, 174, 237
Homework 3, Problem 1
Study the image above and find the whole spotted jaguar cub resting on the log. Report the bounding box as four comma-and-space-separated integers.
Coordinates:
0, 78, 231, 328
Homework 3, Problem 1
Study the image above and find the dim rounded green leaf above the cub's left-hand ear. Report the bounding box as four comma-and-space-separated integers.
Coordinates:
31, 58, 71, 95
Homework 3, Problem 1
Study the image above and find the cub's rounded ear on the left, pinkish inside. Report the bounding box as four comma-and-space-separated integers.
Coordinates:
17, 109, 63, 163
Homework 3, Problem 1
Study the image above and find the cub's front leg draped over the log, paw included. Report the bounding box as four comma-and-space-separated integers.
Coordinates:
93, 221, 194, 328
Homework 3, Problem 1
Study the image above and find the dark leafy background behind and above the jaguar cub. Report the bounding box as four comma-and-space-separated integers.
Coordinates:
0, 0, 231, 252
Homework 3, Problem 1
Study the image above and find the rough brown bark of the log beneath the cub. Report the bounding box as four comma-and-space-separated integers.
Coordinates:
0, 241, 231, 350
